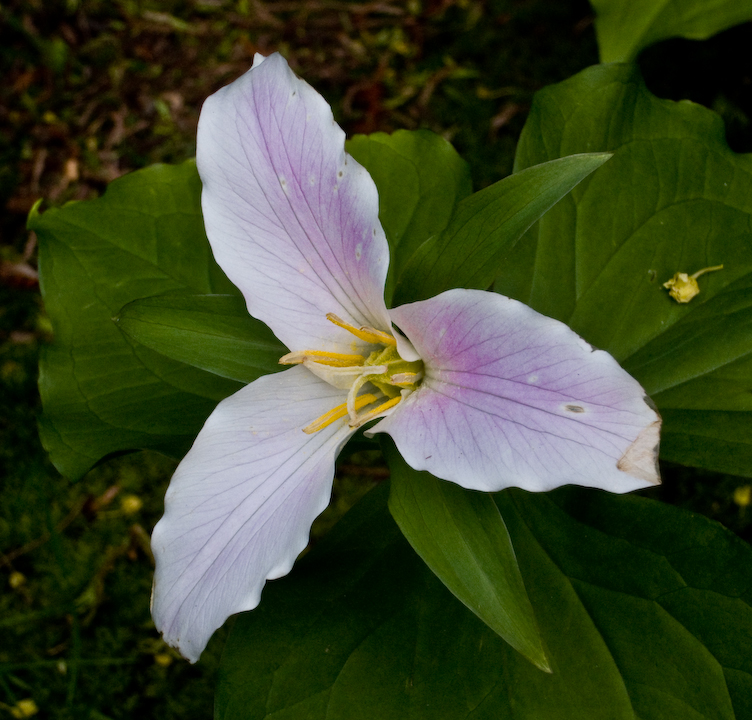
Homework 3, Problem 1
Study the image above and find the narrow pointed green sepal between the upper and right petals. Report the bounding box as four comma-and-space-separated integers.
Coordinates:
395, 153, 611, 305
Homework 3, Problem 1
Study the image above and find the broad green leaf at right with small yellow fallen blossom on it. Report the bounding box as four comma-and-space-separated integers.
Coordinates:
512, 65, 752, 476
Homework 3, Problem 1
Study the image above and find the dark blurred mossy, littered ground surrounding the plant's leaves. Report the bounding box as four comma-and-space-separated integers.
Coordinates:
0, 0, 752, 720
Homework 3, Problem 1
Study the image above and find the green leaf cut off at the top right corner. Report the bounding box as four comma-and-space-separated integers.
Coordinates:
590, 0, 752, 63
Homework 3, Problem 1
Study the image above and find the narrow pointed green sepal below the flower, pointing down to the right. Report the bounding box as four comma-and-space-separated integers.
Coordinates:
385, 444, 551, 672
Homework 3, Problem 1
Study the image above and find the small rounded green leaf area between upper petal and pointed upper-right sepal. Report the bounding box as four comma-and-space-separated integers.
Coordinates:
347, 130, 473, 303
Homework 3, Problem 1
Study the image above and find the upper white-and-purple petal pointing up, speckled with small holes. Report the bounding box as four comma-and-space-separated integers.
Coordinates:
196, 53, 390, 352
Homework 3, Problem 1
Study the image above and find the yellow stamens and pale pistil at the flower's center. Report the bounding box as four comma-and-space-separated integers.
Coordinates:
279, 313, 423, 433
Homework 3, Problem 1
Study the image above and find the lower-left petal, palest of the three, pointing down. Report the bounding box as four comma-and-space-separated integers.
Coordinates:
152, 366, 354, 662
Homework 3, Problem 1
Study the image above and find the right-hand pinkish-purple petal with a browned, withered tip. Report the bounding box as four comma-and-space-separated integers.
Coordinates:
372, 290, 660, 492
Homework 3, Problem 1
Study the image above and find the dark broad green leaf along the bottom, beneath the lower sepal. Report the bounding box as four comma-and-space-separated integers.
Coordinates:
215, 478, 752, 720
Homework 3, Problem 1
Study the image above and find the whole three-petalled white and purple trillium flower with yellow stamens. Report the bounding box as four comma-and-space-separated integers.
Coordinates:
152, 54, 660, 661
